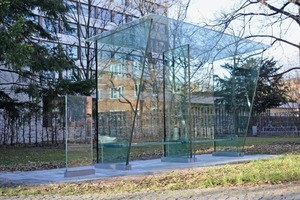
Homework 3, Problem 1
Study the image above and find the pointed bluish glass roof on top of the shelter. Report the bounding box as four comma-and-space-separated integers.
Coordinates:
88, 15, 268, 61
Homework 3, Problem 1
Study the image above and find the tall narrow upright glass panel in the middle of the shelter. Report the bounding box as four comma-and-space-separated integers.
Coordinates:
164, 45, 192, 157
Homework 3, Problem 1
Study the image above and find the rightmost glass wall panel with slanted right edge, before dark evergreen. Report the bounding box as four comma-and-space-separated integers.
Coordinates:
214, 59, 259, 153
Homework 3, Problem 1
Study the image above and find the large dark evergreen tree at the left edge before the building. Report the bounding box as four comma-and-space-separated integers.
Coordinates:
0, 0, 74, 118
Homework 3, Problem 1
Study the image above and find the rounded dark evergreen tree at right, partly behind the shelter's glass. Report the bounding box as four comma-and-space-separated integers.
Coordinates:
215, 59, 288, 113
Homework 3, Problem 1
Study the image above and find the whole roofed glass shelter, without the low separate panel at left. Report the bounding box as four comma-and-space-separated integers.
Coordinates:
90, 15, 266, 169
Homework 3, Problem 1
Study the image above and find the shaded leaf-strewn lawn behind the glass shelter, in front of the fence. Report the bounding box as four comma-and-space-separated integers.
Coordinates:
0, 137, 300, 171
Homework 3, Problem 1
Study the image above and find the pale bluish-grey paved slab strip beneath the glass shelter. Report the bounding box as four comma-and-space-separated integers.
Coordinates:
0, 154, 274, 184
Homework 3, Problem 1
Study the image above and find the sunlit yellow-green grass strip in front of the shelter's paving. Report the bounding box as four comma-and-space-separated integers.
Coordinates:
0, 153, 300, 196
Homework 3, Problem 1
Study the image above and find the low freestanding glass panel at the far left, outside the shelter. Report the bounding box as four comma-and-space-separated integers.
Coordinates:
65, 96, 93, 169
